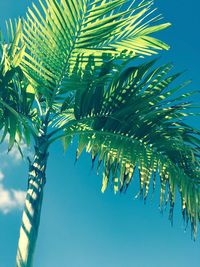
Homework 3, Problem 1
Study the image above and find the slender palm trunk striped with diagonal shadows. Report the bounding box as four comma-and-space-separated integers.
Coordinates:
16, 138, 48, 267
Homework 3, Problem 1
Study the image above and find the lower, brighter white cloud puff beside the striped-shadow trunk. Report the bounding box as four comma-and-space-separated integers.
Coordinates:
0, 184, 25, 214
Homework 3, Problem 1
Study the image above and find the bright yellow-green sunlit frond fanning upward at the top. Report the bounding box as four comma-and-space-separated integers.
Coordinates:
22, 0, 170, 99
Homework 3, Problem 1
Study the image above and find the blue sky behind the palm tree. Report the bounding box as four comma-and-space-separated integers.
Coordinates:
0, 0, 200, 267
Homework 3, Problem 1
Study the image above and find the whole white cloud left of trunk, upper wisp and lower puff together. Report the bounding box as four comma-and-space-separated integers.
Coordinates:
0, 139, 27, 214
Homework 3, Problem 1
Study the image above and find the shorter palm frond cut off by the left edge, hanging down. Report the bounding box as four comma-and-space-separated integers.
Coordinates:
0, 19, 35, 149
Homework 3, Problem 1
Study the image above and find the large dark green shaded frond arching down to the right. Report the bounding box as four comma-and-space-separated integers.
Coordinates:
52, 59, 200, 240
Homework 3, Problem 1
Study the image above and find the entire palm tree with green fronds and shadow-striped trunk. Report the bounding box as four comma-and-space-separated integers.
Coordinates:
0, 0, 200, 267
